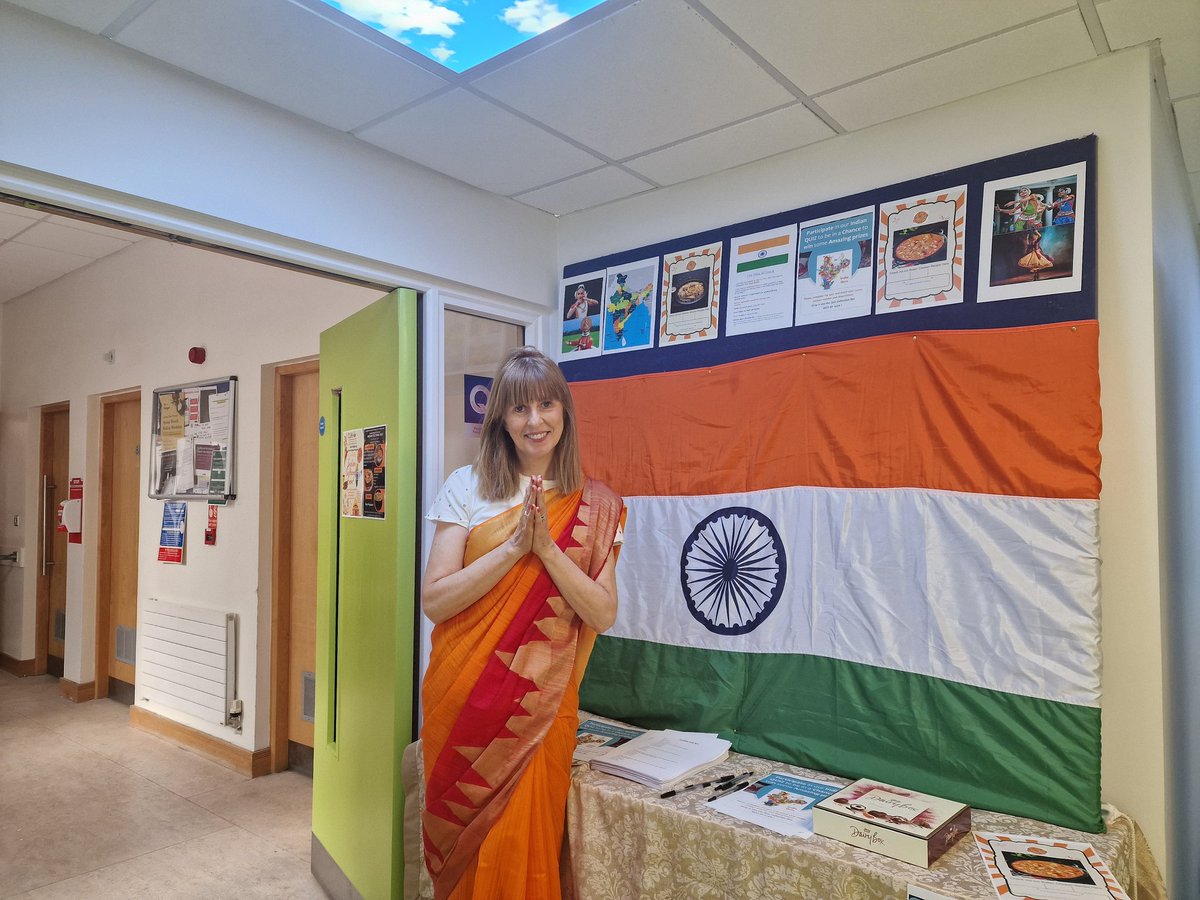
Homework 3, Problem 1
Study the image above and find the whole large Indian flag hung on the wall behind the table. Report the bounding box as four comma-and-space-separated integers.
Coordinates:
572, 320, 1102, 832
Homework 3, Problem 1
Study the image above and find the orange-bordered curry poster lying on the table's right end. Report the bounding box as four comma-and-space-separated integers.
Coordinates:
974, 832, 1129, 900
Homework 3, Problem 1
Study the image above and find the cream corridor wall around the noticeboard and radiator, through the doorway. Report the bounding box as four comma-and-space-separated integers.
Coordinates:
0, 240, 380, 749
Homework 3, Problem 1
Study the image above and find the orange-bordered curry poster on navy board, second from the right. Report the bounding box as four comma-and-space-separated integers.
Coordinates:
875, 185, 967, 313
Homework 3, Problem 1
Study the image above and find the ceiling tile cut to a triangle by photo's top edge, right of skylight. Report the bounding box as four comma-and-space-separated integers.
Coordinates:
704, 0, 1075, 94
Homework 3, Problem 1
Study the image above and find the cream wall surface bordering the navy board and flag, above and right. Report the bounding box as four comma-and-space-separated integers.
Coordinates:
559, 48, 1176, 888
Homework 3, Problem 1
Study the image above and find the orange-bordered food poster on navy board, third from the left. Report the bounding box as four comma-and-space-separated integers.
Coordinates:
659, 241, 721, 347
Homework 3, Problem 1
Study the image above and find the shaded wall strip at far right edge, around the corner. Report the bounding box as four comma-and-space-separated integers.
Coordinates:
1151, 54, 1200, 896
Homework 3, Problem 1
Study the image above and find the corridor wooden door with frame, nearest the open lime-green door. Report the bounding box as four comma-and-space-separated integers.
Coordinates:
271, 361, 319, 772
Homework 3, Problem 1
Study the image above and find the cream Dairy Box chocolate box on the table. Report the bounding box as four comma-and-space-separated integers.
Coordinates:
812, 779, 971, 869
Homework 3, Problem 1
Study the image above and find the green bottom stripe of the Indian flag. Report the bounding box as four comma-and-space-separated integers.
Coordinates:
580, 635, 1103, 833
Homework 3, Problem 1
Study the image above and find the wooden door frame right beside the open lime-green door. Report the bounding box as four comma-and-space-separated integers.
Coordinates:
268, 358, 320, 773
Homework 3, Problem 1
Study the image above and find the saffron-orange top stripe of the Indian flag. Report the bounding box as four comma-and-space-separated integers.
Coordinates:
571, 322, 1100, 499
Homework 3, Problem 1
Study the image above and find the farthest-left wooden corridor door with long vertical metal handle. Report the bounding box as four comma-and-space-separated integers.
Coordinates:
35, 403, 71, 677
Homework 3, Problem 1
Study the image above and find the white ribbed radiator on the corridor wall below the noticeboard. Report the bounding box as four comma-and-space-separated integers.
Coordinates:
137, 598, 241, 731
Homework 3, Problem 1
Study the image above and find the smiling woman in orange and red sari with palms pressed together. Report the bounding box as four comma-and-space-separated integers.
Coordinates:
421, 347, 624, 900
